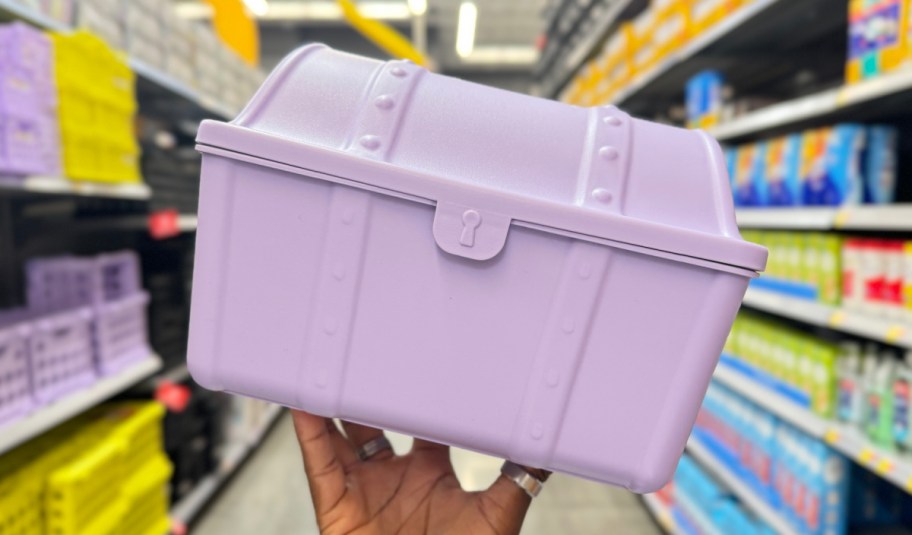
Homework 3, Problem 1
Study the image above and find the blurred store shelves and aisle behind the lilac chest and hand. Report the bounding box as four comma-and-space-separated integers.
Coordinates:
0, 0, 912, 535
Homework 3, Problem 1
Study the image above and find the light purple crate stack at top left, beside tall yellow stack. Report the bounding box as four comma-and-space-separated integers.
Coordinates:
0, 23, 60, 176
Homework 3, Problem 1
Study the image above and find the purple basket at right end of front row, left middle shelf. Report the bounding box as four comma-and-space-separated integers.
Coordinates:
94, 292, 151, 375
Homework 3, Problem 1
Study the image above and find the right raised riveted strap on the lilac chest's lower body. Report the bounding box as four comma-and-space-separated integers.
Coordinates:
509, 241, 613, 462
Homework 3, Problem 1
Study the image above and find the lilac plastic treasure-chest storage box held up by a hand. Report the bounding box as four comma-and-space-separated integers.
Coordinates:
189, 45, 766, 492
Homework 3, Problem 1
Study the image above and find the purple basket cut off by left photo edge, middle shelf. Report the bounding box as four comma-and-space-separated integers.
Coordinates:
0, 311, 33, 425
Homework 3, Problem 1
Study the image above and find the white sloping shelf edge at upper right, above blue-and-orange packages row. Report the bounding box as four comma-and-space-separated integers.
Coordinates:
709, 70, 912, 141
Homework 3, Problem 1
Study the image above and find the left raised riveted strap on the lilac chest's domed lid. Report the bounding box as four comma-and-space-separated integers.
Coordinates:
346, 60, 426, 161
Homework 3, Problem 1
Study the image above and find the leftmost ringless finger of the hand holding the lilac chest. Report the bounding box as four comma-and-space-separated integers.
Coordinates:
291, 410, 353, 517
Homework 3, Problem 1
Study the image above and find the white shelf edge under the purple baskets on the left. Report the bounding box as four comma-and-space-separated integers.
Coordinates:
0, 355, 162, 453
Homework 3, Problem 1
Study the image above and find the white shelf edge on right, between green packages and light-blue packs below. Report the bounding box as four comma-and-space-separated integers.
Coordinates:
716, 366, 912, 493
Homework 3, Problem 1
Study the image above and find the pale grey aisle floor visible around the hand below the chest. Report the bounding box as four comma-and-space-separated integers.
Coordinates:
193, 415, 660, 535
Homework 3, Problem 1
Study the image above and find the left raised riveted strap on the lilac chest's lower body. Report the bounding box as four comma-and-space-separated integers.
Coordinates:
297, 185, 373, 414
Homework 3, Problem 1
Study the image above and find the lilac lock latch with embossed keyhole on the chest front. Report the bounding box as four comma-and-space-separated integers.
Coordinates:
434, 201, 510, 260
